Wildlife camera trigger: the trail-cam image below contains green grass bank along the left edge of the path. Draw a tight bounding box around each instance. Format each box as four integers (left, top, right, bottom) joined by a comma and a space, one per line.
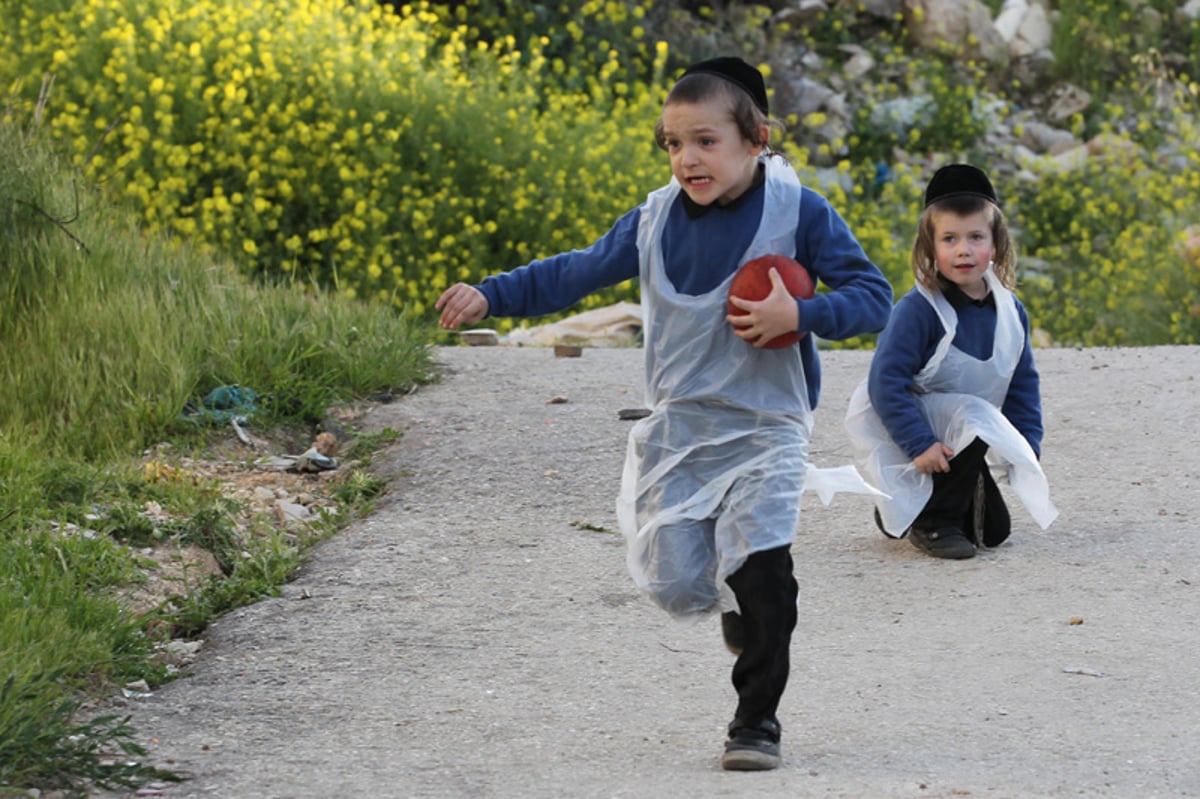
0, 114, 430, 794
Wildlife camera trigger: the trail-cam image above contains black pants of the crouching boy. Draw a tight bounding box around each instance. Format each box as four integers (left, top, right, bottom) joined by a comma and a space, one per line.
912, 438, 1012, 547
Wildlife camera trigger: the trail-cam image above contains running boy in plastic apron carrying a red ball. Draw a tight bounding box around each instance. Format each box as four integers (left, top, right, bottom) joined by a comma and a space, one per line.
436, 58, 892, 770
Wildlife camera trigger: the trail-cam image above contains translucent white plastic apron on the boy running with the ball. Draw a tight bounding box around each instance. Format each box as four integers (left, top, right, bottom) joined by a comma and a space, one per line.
617, 158, 812, 617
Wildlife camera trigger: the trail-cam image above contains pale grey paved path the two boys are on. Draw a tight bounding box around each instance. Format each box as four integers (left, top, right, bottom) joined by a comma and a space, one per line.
100, 348, 1200, 799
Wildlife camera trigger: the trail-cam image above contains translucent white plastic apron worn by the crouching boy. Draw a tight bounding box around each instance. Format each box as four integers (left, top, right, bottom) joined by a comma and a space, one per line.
846, 269, 1058, 537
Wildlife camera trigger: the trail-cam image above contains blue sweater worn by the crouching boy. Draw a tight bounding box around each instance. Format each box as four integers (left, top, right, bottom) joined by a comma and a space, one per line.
868, 284, 1043, 458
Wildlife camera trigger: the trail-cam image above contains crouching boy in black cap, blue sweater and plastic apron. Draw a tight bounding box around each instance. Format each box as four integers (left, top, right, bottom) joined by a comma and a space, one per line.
846, 164, 1057, 559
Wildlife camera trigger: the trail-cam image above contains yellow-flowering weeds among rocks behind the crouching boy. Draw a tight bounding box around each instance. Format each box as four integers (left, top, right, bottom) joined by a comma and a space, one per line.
793, 0, 1200, 346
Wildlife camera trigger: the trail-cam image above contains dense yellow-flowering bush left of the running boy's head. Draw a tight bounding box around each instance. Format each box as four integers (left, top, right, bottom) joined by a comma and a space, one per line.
0, 0, 666, 323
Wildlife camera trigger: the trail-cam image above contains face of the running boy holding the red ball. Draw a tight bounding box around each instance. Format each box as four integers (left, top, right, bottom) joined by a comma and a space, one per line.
662, 100, 766, 205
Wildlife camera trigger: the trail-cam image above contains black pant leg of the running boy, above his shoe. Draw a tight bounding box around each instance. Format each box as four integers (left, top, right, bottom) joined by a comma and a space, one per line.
725, 546, 799, 731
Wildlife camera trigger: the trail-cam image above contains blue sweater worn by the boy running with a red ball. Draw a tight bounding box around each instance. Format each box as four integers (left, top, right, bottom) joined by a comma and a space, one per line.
476, 176, 892, 408
